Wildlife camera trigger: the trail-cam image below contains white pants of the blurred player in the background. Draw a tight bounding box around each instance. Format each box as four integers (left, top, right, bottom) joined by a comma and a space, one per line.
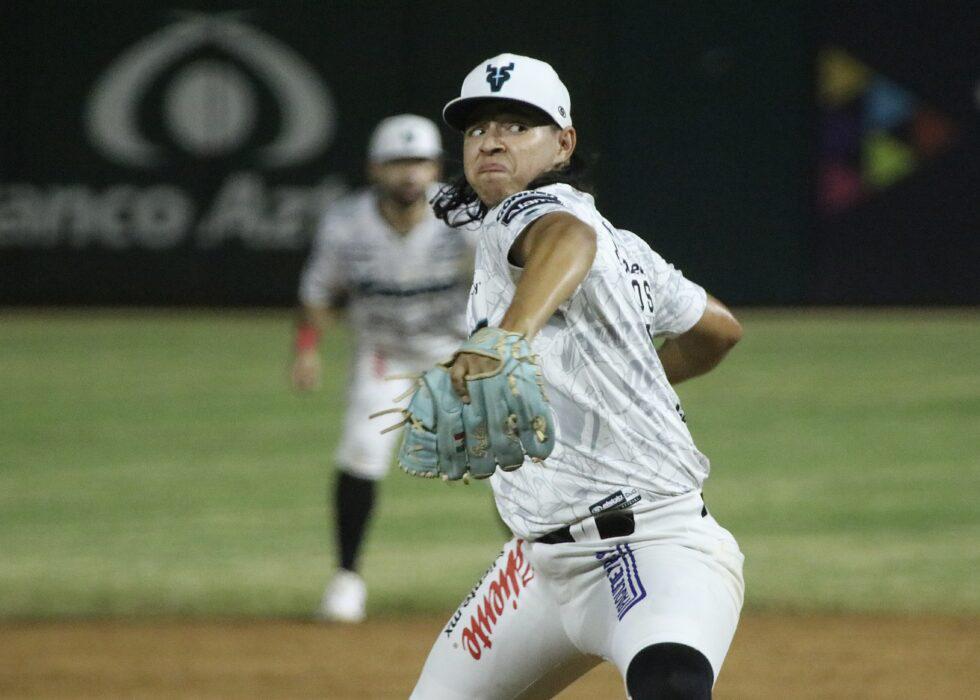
336, 348, 416, 480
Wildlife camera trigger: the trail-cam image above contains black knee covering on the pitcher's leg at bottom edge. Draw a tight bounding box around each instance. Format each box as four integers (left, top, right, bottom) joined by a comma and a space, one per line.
626, 643, 715, 700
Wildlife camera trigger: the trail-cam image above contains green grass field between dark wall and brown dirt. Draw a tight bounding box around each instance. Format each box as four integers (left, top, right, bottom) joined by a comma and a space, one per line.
0, 311, 980, 618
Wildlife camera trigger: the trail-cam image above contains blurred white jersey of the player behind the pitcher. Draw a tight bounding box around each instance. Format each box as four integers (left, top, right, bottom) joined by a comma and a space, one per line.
299, 189, 473, 358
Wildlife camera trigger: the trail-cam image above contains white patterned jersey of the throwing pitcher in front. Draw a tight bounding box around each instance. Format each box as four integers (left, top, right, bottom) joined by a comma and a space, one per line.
467, 185, 709, 539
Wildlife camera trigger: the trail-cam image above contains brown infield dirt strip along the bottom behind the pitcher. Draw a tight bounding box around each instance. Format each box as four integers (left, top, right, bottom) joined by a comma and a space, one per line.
0, 614, 980, 700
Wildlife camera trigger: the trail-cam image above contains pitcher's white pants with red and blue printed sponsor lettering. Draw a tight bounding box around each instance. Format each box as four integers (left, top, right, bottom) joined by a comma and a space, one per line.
412, 493, 744, 700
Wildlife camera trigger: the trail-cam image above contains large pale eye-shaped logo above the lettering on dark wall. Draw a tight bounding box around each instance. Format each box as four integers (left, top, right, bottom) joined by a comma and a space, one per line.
85, 15, 336, 168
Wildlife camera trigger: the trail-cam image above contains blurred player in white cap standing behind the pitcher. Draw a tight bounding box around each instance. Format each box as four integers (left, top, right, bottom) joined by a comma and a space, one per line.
293, 114, 473, 622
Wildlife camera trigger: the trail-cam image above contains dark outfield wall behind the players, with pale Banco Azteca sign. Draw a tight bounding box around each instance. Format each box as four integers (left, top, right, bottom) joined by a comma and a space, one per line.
0, 0, 980, 305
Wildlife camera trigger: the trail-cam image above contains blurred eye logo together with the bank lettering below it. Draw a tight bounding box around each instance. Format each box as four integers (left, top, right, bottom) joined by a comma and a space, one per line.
0, 13, 348, 251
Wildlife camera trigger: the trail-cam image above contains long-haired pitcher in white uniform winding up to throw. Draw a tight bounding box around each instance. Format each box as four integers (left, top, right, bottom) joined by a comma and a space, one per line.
399, 54, 743, 699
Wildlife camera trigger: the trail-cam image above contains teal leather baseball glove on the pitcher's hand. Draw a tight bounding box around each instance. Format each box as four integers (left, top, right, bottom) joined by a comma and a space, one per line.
375, 328, 555, 481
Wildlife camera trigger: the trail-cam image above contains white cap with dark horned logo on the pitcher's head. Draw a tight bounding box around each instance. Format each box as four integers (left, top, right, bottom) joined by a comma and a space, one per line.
442, 53, 572, 131
